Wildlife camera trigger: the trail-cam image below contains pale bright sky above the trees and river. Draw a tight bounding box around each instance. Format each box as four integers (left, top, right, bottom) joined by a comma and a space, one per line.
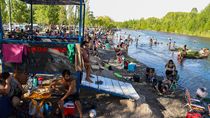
90, 0, 210, 21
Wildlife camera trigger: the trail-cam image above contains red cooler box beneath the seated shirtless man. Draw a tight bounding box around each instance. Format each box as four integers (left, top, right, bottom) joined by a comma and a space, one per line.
64, 101, 75, 116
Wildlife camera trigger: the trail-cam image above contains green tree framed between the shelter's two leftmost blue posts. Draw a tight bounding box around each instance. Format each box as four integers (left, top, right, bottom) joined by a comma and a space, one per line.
11, 0, 30, 23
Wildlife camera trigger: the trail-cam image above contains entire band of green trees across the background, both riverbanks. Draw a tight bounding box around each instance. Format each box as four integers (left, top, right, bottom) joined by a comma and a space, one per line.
0, 0, 210, 37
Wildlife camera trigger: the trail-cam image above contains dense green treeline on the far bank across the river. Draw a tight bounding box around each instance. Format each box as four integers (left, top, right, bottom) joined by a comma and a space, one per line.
116, 4, 210, 37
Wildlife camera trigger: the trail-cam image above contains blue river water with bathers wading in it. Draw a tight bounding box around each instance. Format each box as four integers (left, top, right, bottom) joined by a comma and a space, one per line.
116, 30, 210, 95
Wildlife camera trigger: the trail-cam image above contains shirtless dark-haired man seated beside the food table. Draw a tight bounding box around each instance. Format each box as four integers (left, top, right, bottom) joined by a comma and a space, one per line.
50, 70, 82, 118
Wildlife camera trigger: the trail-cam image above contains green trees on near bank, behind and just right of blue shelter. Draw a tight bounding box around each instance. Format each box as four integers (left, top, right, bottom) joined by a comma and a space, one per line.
0, 0, 115, 28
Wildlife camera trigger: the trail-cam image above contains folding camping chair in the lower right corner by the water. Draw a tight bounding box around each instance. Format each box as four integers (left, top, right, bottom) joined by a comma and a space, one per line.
185, 89, 205, 112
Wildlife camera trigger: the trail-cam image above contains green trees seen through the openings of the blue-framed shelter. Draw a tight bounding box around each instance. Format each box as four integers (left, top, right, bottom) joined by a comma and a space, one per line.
0, 0, 78, 25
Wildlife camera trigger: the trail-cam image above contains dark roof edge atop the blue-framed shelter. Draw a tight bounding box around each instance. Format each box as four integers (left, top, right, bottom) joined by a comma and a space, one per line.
21, 0, 84, 5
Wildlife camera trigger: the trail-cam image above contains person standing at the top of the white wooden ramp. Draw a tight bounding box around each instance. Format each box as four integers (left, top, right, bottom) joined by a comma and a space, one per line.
81, 41, 93, 83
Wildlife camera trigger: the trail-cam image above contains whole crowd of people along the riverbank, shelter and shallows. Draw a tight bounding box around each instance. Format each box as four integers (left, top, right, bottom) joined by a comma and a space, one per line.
0, 28, 209, 118
